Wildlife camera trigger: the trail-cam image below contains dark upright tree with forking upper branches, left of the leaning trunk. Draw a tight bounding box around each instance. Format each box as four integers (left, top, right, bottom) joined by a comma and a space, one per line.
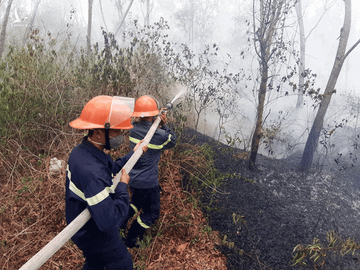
249, 0, 291, 169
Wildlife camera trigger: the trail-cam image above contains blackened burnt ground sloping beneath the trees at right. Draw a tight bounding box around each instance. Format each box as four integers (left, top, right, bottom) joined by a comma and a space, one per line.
183, 131, 360, 270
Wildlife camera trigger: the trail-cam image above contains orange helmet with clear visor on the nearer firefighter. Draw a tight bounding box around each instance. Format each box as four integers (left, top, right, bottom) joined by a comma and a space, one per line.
69, 96, 133, 129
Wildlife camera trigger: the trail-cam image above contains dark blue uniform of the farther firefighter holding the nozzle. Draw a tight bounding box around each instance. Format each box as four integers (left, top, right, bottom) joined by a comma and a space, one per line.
123, 121, 176, 247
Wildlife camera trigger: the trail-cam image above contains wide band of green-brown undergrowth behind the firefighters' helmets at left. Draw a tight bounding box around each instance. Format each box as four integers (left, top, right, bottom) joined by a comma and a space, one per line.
0, 19, 179, 151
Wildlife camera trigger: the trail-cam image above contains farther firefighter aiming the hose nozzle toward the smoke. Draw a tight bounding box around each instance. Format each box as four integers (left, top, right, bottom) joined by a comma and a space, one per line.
122, 95, 176, 248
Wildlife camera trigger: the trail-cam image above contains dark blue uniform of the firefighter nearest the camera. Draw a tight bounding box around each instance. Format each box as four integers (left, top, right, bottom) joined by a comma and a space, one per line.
66, 137, 133, 269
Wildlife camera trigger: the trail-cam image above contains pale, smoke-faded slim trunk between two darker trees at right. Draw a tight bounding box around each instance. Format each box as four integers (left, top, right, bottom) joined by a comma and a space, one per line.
295, 0, 306, 108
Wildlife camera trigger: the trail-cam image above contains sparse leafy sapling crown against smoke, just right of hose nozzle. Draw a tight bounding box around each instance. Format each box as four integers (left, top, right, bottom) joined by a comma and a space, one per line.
177, 44, 246, 133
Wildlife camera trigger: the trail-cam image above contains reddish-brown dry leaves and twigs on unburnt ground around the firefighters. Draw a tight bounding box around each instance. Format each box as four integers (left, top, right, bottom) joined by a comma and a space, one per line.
0, 140, 227, 270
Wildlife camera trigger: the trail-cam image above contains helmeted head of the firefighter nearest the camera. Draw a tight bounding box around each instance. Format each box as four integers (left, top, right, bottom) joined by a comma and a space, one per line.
69, 96, 133, 149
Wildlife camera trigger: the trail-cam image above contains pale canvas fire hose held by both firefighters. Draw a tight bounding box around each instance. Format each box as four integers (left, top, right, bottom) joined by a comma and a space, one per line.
19, 103, 173, 270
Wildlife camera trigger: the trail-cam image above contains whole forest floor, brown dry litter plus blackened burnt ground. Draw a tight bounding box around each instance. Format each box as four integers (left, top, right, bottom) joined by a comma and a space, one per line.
0, 127, 360, 270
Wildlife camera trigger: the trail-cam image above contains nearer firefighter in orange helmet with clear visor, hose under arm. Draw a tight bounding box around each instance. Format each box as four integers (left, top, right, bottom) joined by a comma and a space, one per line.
65, 96, 147, 270
